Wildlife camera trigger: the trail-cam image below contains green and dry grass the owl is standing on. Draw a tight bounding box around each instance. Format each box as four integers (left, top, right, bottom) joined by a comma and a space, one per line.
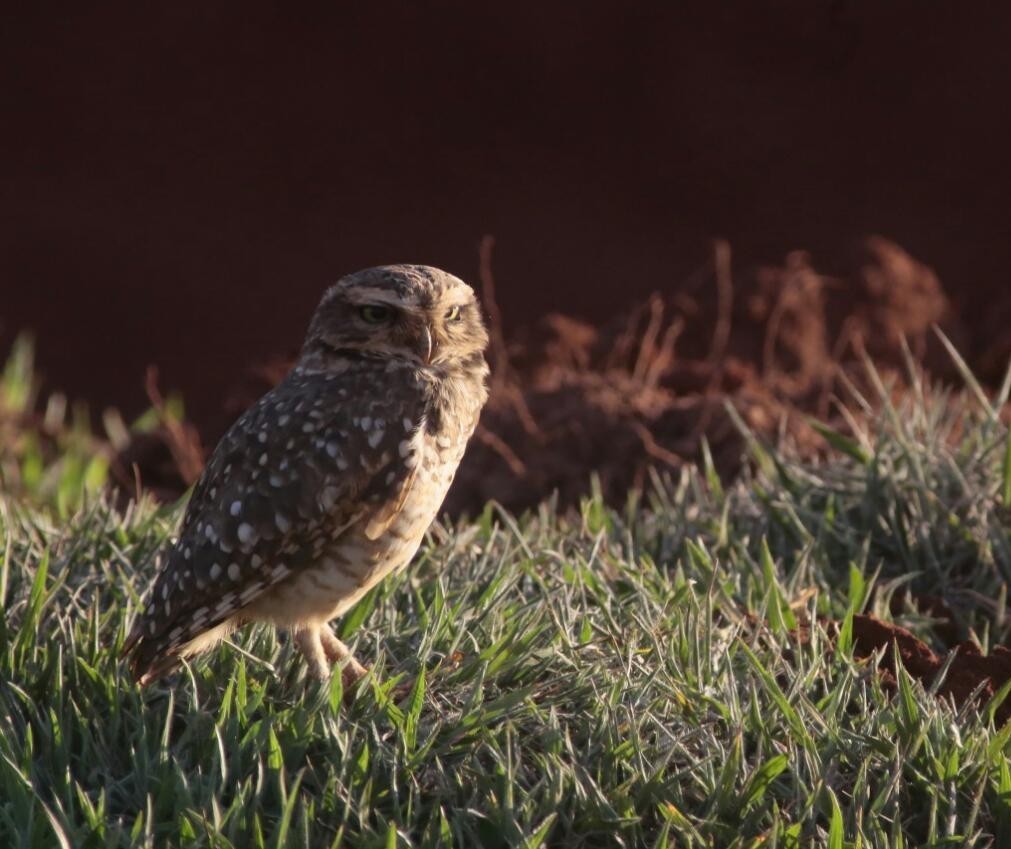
0, 341, 1011, 849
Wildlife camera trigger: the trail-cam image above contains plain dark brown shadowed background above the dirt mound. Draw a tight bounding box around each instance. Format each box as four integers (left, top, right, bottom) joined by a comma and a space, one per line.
0, 0, 1011, 419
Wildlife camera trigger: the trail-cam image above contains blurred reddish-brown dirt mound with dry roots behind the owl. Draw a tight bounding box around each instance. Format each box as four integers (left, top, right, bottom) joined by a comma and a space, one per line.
108, 237, 978, 514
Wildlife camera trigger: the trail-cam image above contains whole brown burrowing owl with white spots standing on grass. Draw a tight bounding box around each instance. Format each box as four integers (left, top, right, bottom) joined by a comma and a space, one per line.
124, 265, 488, 684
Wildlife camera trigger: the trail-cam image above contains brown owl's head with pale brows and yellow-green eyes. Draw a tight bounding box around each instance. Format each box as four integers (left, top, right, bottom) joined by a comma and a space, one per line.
302, 265, 488, 366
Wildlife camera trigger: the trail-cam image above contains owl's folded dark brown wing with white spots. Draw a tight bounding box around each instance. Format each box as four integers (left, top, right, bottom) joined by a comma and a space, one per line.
123, 364, 426, 682
